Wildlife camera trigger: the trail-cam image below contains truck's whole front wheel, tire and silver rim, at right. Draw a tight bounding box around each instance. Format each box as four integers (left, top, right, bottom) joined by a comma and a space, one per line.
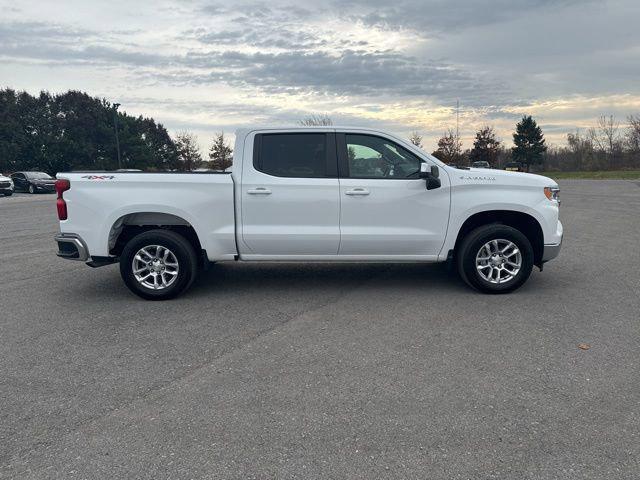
456, 224, 533, 294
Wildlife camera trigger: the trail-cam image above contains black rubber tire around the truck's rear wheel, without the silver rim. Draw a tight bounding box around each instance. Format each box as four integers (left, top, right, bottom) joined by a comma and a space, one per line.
120, 230, 198, 300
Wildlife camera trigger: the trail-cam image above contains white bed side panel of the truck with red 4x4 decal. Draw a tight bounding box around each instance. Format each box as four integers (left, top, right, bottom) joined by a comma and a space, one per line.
57, 172, 237, 260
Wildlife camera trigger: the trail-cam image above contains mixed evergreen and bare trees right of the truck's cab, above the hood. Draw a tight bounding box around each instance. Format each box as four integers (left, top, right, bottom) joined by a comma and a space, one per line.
409, 115, 640, 171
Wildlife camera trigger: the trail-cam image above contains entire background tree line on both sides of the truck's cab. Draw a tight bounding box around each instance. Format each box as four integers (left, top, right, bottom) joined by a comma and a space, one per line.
5, 88, 640, 174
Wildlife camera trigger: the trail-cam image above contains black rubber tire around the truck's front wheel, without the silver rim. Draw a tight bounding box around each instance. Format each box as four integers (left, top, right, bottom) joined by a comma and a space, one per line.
458, 225, 534, 293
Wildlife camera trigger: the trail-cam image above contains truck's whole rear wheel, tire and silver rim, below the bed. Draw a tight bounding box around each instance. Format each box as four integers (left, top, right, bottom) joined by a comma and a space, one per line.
120, 230, 198, 300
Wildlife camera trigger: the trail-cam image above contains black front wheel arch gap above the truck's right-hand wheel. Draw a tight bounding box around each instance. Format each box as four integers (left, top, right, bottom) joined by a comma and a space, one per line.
454, 210, 544, 266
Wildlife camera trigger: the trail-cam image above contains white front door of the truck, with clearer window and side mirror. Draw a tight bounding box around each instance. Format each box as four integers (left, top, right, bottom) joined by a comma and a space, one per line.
336, 133, 450, 260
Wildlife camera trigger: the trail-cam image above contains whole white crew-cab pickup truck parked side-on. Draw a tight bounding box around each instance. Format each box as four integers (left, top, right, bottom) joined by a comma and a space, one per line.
55, 127, 562, 299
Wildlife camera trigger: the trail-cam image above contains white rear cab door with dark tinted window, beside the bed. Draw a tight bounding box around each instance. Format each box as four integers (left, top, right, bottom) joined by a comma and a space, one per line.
240, 130, 340, 259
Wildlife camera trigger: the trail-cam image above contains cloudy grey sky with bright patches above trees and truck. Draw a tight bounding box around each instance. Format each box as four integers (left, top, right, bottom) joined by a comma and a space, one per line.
0, 0, 640, 150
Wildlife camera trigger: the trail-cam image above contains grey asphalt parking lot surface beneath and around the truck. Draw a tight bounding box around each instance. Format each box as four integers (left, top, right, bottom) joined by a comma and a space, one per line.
0, 181, 640, 479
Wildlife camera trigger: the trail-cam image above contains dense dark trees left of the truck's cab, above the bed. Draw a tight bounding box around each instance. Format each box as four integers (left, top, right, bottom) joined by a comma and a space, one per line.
0, 88, 233, 175
